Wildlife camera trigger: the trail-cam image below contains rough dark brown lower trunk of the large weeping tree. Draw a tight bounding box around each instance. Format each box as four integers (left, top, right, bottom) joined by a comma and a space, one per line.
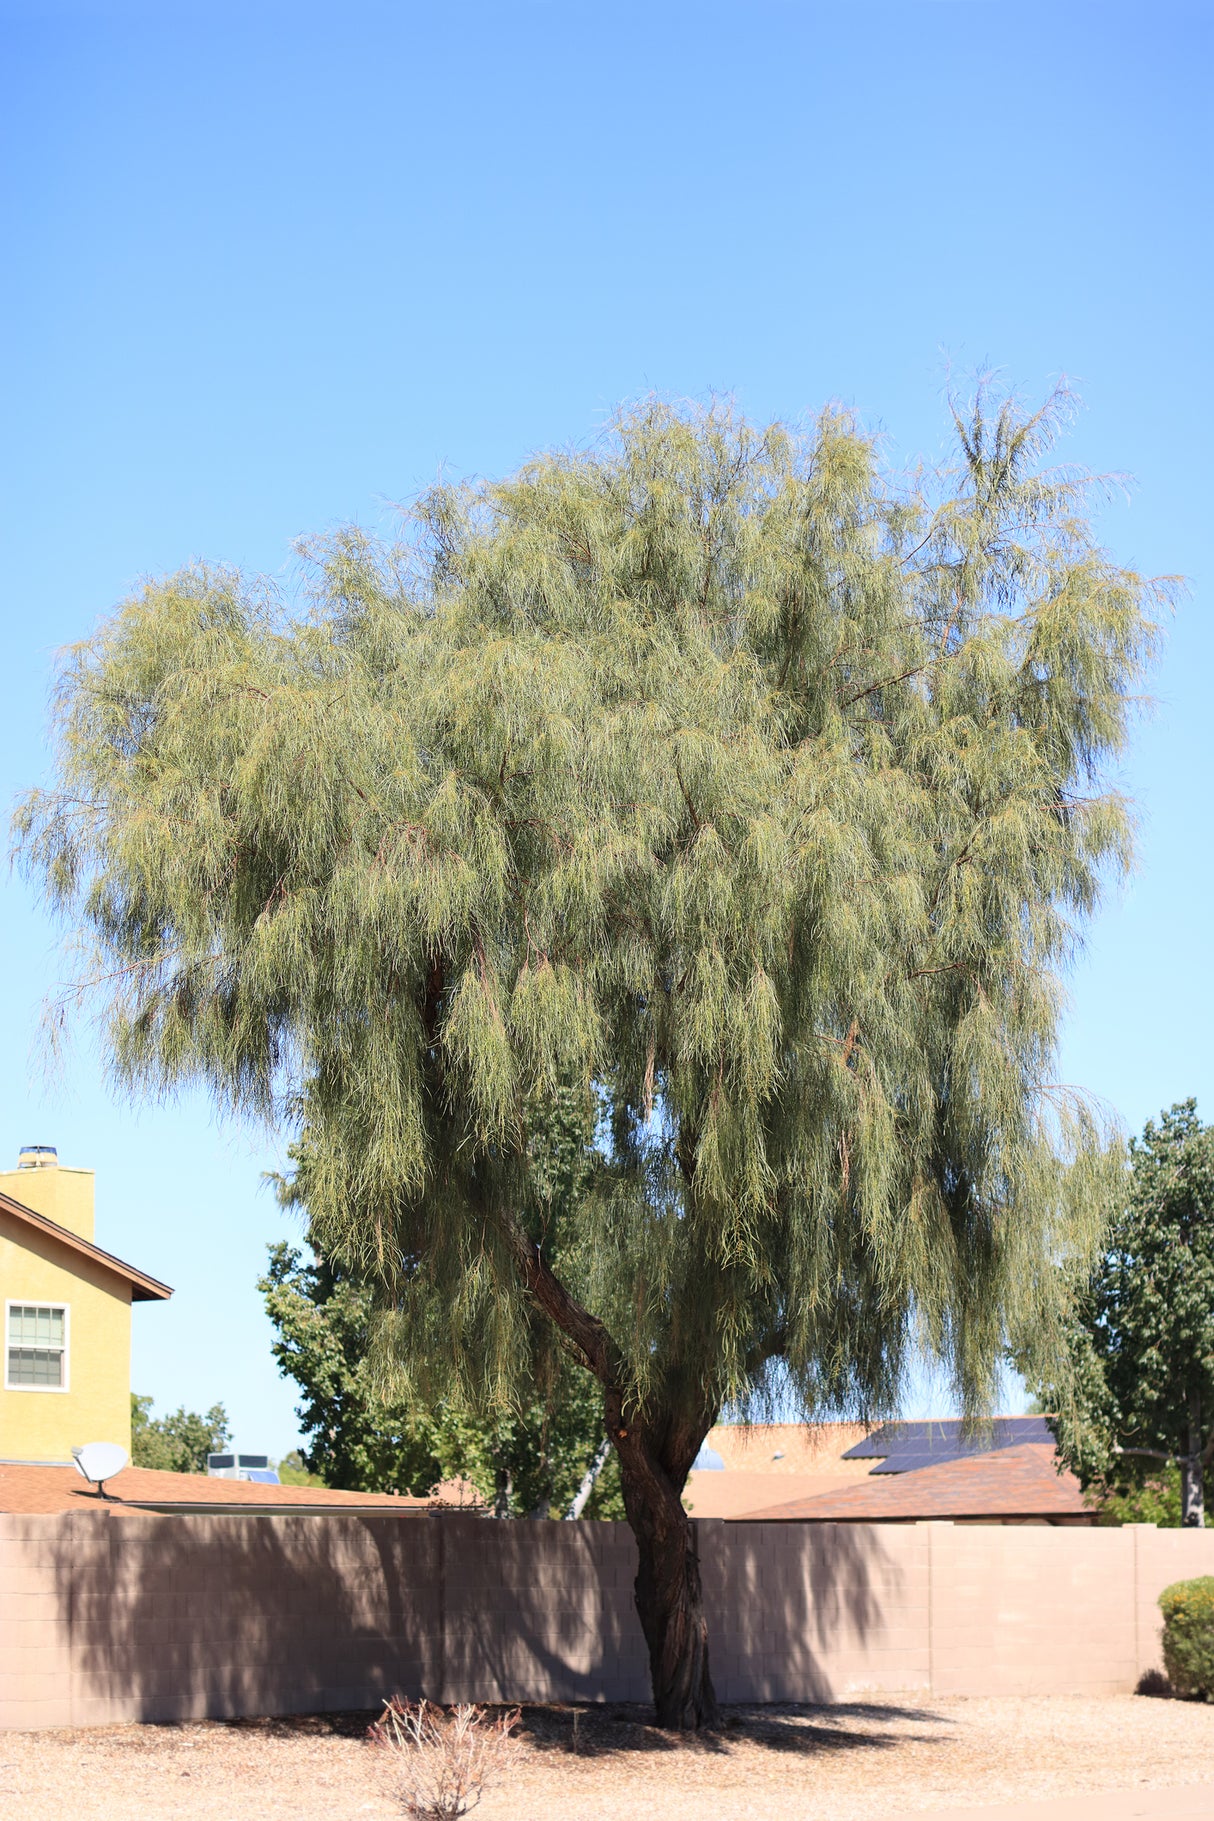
615, 1431, 717, 1732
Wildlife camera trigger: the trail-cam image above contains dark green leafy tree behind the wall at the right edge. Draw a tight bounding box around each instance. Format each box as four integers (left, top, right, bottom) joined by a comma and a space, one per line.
1047, 1100, 1214, 1526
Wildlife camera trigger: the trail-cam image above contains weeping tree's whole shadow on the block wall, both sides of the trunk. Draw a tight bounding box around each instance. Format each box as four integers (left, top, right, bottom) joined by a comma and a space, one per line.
40, 1511, 928, 1724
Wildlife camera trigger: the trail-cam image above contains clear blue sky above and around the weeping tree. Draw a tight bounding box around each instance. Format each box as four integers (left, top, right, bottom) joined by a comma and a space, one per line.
0, 0, 1214, 1451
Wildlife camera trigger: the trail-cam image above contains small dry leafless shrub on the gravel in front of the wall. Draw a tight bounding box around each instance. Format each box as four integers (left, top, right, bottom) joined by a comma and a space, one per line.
368, 1695, 519, 1821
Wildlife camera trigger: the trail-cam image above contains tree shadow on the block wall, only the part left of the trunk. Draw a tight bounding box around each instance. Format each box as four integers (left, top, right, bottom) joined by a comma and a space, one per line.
45, 1513, 648, 1724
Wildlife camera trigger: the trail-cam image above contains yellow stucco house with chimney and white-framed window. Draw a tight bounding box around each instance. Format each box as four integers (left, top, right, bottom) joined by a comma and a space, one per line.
0, 1145, 173, 1462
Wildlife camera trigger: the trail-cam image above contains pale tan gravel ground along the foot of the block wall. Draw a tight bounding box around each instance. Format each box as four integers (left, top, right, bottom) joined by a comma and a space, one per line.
0, 1695, 1214, 1821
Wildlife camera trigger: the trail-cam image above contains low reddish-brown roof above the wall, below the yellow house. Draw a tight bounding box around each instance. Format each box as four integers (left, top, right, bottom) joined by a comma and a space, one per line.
0, 1460, 433, 1517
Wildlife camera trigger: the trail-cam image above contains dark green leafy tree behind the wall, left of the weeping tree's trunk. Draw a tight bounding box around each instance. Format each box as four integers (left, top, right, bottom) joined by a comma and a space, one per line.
258, 1246, 622, 1517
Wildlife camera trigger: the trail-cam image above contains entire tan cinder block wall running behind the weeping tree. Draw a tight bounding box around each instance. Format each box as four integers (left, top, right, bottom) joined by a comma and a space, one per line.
0, 1511, 1214, 1728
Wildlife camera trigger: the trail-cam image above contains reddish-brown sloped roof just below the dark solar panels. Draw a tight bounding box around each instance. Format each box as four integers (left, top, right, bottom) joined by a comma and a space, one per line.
739, 1442, 1092, 1524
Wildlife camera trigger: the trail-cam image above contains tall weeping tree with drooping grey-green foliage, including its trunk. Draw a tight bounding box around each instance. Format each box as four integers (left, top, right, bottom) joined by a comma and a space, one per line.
18, 384, 1161, 1726
